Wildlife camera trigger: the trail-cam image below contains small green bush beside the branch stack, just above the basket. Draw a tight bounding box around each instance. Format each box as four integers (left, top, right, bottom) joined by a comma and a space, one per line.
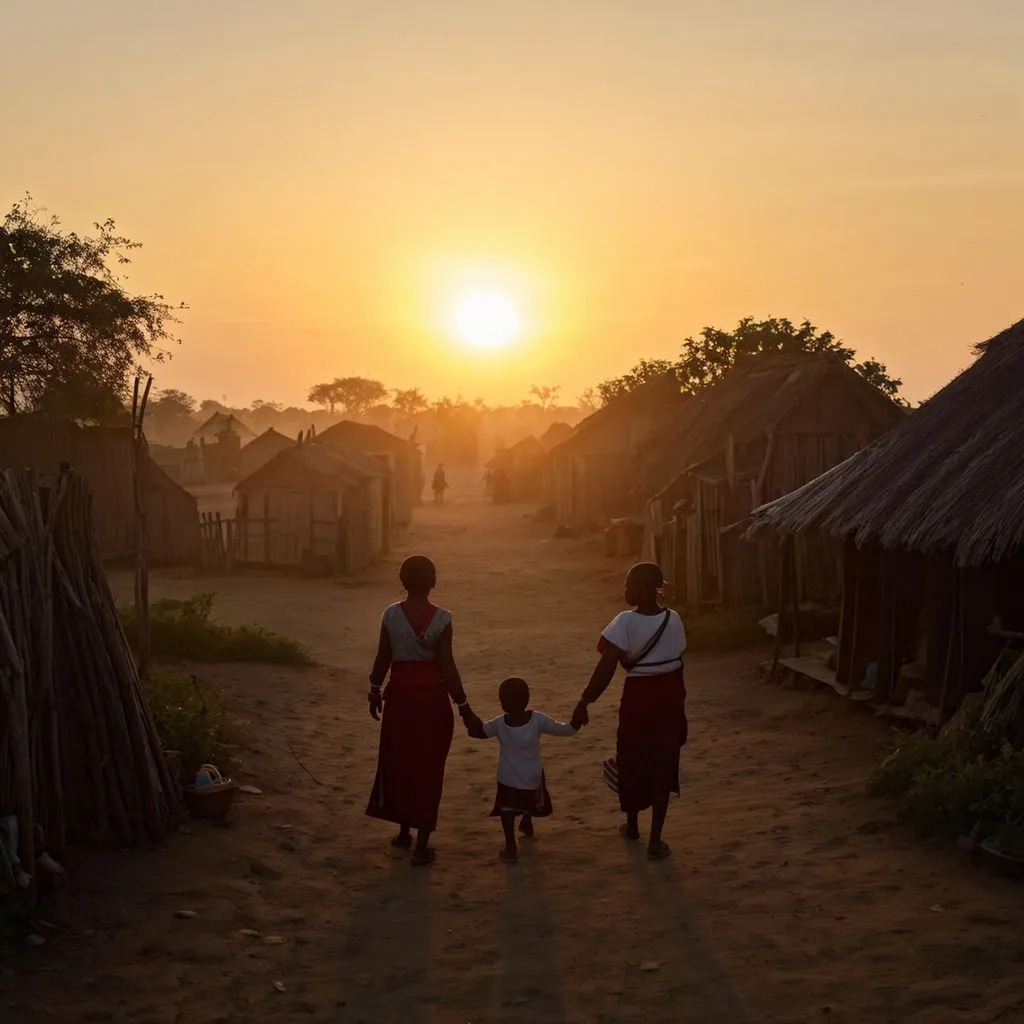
142, 669, 231, 770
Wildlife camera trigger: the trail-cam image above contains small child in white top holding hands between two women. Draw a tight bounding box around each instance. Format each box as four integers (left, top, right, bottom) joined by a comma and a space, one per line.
465, 679, 580, 864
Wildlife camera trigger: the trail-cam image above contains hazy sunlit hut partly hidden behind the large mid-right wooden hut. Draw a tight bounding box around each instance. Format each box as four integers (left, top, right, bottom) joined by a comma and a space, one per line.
551, 374, 684, 534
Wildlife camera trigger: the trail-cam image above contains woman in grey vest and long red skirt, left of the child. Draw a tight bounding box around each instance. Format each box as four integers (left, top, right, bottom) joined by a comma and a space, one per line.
367, 555, 469, 866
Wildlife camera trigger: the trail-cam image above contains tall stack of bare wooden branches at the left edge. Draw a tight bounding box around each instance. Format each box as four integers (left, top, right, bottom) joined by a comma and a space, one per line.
0, 467, 173, 880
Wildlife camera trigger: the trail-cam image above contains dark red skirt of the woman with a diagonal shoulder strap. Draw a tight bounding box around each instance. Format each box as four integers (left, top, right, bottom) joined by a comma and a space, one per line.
615, 669, 687, 814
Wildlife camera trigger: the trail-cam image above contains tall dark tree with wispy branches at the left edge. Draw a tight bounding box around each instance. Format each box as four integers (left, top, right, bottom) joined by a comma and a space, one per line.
0, 197, 184, 420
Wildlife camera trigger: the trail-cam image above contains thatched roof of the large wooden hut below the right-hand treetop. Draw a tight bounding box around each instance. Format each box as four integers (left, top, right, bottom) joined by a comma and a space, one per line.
638, 352, 905, 494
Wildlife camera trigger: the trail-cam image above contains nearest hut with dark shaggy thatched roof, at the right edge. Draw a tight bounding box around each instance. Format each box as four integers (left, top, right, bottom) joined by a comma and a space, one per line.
751, 321, 1024, 722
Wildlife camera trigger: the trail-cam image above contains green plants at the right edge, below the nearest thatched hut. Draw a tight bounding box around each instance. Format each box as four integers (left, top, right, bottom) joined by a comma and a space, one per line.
868, 735, 1024, 856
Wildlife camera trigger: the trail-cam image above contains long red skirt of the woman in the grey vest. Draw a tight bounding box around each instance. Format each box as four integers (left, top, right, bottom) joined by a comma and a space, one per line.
367, 662, 455, 831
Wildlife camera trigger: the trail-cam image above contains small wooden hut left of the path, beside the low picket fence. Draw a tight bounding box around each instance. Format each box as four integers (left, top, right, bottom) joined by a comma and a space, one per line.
234, 443, 392, 575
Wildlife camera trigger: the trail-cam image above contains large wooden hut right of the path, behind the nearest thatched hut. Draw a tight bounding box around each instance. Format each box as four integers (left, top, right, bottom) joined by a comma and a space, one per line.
638, 353, 905, 610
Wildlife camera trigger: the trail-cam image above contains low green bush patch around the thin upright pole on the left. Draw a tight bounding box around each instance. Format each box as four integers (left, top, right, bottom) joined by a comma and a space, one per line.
119, 594, 312, 665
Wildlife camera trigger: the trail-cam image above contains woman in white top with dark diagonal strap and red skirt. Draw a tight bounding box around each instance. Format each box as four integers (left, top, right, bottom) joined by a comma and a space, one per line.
572, 562, 687, 860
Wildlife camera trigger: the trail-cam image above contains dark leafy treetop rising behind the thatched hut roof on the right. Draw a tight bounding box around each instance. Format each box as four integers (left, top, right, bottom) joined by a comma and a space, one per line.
677, 316, 903, 398
